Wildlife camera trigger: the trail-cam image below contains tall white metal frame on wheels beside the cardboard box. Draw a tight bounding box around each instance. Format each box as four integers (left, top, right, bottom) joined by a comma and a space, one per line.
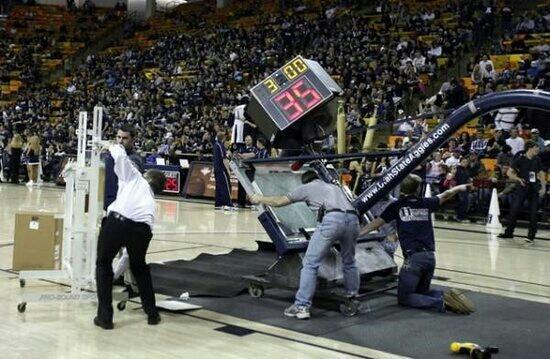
18, 106, 127, 312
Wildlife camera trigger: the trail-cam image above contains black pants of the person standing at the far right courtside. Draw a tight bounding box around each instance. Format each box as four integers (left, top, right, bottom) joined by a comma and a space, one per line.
506, 184, 539, 238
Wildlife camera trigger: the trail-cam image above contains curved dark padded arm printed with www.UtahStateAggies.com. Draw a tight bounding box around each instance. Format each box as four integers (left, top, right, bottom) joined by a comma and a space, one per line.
353, 90, 550, 213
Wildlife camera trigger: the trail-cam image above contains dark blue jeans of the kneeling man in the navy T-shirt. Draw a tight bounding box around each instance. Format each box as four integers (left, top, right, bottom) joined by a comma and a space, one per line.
397, 251, 445, 312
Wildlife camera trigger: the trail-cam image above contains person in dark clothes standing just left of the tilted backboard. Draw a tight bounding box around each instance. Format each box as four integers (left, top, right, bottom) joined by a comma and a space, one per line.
212, 131, 234, 210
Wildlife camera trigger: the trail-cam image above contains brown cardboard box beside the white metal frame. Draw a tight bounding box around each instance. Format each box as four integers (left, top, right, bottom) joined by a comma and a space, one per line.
13, 211, 63, 270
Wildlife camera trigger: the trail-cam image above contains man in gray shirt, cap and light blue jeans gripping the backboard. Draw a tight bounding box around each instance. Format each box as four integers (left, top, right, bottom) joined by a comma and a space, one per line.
250, 171, 359, 319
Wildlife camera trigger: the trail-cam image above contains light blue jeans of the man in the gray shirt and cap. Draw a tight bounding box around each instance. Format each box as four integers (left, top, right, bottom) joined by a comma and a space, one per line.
294, 212, 360, 307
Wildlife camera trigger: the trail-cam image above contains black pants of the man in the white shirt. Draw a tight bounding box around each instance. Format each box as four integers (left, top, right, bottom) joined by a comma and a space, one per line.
96, 213, 158, 322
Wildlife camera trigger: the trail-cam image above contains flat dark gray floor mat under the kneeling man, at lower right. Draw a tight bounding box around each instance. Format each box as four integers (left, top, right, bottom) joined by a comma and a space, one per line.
192, 289, 550, 359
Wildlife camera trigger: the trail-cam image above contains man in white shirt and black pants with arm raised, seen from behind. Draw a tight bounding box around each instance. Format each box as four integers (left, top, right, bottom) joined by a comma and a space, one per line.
94, 144, 166, 329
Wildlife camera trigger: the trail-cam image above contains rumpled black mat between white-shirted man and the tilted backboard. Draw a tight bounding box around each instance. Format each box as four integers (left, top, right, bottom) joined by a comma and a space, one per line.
151, 249, 277, 297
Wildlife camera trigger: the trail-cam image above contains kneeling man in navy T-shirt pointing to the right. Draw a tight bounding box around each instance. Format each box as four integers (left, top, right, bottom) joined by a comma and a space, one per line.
361, 175, 474, 314
